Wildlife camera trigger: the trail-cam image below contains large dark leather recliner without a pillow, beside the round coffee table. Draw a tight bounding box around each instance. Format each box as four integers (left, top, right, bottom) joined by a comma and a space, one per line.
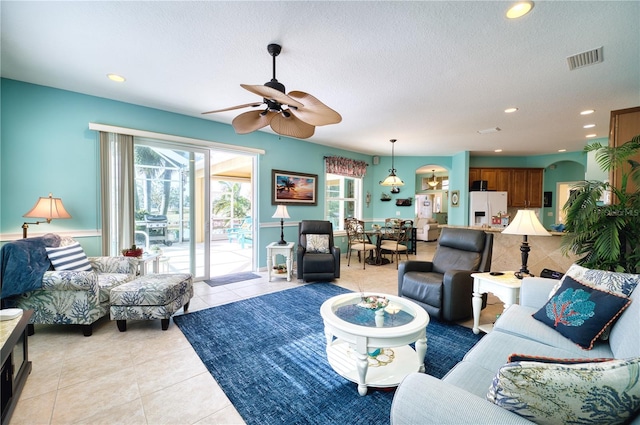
398, 228, 493, 321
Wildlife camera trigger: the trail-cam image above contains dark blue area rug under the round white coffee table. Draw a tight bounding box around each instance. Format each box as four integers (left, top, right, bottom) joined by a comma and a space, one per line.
174, 283, 480, 425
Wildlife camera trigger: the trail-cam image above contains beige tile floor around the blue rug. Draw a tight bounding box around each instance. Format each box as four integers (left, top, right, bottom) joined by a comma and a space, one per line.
10, 242, 502, 425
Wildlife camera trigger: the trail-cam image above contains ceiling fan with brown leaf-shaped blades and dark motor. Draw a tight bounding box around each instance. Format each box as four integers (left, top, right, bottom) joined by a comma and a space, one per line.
203, 44, 342, 139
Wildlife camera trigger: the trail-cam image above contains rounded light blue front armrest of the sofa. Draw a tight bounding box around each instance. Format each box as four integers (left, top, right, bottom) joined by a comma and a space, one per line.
390, 373, 532, 425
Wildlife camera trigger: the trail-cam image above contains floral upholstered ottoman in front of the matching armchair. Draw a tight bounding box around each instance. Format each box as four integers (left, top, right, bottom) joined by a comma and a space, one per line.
110, 273, 193, 332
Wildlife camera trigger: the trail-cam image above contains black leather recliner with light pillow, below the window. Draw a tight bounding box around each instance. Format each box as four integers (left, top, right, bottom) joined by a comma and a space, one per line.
297, 220, 340, 282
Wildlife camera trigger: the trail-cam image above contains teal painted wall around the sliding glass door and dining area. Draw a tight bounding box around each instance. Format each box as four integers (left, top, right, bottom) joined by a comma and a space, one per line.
0, 79, 587, 267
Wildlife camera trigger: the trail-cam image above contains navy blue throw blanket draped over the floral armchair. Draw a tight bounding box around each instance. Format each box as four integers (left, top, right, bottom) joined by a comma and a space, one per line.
0, 233, 60, 299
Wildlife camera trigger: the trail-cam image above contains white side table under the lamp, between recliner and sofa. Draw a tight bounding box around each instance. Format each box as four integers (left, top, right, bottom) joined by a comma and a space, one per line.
471, 272, 522, 334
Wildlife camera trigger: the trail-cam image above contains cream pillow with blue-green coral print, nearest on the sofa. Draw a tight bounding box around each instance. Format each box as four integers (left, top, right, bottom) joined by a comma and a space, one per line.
487, 357, 640, 424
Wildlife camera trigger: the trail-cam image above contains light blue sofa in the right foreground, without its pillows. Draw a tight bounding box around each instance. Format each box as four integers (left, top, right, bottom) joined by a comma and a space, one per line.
390, 278, 640, 425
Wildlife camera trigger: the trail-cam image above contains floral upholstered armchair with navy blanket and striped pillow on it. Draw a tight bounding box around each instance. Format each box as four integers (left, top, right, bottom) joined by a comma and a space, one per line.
2, 234, 138, 336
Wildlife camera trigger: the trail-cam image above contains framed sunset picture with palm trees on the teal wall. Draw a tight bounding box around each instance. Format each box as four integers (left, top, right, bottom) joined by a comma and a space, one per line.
271, 170, 318, 205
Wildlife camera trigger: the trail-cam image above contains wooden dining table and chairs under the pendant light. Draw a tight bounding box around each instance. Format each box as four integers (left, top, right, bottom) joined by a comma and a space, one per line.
344, 218, 413, 269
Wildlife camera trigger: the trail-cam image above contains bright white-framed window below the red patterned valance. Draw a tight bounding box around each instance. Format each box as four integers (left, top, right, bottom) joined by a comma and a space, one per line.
325, 173, 362, 230
